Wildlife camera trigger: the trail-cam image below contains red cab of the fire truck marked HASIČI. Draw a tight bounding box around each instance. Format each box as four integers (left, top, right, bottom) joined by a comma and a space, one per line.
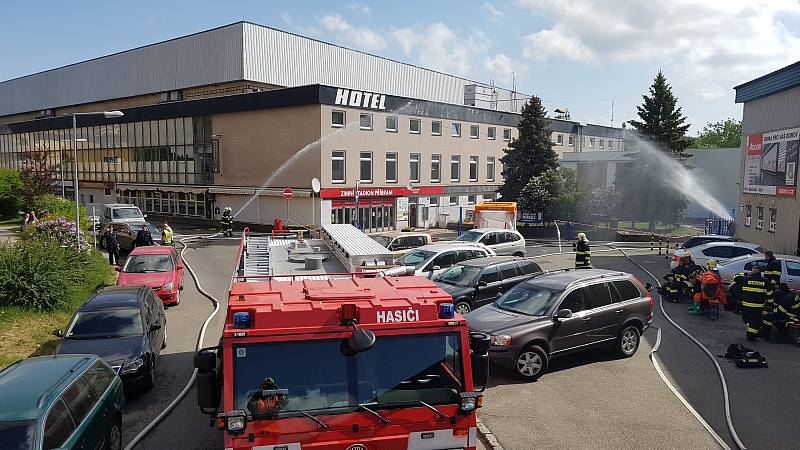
195, 232, 489, 450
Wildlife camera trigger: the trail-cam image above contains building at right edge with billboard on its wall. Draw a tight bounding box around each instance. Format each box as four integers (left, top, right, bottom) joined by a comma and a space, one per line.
735, 62, 800, 255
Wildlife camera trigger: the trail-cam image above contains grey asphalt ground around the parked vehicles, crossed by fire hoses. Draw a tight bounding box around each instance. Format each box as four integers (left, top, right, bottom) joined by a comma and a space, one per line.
115, 240, 800, 449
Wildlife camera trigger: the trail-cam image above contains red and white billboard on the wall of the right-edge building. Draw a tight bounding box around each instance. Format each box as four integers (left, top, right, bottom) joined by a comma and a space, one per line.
744, 127, 800, 197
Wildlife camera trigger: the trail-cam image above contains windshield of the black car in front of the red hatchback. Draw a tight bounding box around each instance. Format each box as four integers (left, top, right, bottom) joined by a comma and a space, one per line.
65, 309, 142, 339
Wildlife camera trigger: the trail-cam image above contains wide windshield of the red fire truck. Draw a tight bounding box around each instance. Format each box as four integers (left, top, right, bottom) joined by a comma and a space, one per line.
232, 333, 464, 419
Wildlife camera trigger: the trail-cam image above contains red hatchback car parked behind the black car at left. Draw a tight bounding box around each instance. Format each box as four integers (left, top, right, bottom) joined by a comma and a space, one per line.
117, 245, 183, 305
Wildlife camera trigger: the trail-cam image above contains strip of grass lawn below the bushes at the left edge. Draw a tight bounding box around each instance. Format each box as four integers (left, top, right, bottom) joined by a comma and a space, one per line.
0, 250, 116, 369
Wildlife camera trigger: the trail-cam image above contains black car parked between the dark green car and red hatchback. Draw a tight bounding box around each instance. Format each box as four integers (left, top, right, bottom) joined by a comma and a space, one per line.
56, 286, 167, 389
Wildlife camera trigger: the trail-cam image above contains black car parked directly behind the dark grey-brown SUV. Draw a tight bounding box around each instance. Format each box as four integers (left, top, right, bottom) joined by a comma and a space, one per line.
433, 256, 542, 315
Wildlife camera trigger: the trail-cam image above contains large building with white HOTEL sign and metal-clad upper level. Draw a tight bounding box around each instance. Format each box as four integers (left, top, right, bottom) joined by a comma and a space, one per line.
0, 22, 618, 230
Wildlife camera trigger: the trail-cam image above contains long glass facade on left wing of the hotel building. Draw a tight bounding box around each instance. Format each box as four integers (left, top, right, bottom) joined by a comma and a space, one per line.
0, 116, 214, 185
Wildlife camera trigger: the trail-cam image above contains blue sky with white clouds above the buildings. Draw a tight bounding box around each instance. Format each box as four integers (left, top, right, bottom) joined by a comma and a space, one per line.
0, 0, 800, 133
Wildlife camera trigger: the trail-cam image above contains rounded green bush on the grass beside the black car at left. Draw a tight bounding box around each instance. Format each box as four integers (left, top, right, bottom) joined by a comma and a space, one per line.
0, 239, 111, 310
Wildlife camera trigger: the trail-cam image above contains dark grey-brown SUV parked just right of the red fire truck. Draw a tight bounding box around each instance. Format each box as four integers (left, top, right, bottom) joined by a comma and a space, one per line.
466, 269, 653, 380
